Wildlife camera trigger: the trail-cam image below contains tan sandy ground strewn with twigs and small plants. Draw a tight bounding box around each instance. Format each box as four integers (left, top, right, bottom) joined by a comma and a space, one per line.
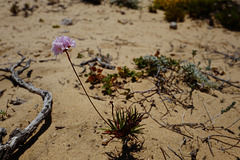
0, 0, 240, 160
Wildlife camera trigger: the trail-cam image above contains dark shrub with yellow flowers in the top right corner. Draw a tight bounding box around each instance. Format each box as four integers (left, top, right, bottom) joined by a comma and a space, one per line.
151, 0, 240, 31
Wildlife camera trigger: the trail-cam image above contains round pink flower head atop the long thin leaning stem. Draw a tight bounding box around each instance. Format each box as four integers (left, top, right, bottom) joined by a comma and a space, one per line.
52, 36, 76, 55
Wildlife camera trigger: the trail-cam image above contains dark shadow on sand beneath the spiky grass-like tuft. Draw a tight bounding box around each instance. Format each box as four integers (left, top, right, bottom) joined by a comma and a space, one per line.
105, 141, 144, 160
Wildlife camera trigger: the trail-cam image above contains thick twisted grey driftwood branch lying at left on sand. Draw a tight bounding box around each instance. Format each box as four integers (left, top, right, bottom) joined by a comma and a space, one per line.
0, 52, 52, 160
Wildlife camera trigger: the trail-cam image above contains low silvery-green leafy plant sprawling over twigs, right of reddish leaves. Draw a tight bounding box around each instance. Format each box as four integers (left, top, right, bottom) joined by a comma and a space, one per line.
133, 51, 218, 90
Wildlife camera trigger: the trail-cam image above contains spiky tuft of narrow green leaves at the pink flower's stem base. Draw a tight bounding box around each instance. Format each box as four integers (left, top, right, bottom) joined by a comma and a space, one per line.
103, 103, 144, 143
